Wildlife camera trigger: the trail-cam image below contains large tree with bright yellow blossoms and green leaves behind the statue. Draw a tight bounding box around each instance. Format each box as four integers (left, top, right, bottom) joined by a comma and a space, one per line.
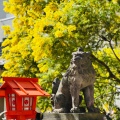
2, 0, 120, 118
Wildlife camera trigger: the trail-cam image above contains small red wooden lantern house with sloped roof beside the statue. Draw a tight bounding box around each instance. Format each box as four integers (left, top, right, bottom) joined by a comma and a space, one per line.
0, 77, 49, 120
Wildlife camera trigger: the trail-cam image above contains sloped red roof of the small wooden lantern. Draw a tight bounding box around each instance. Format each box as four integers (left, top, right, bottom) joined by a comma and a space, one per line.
0, 77, 50, 96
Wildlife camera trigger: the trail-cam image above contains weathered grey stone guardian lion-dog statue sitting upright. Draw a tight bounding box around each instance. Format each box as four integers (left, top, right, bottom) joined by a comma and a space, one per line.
52, 48, 99, 113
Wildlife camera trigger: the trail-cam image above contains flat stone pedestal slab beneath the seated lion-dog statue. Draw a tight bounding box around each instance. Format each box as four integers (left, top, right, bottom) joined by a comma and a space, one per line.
42, 113, 106, 120
